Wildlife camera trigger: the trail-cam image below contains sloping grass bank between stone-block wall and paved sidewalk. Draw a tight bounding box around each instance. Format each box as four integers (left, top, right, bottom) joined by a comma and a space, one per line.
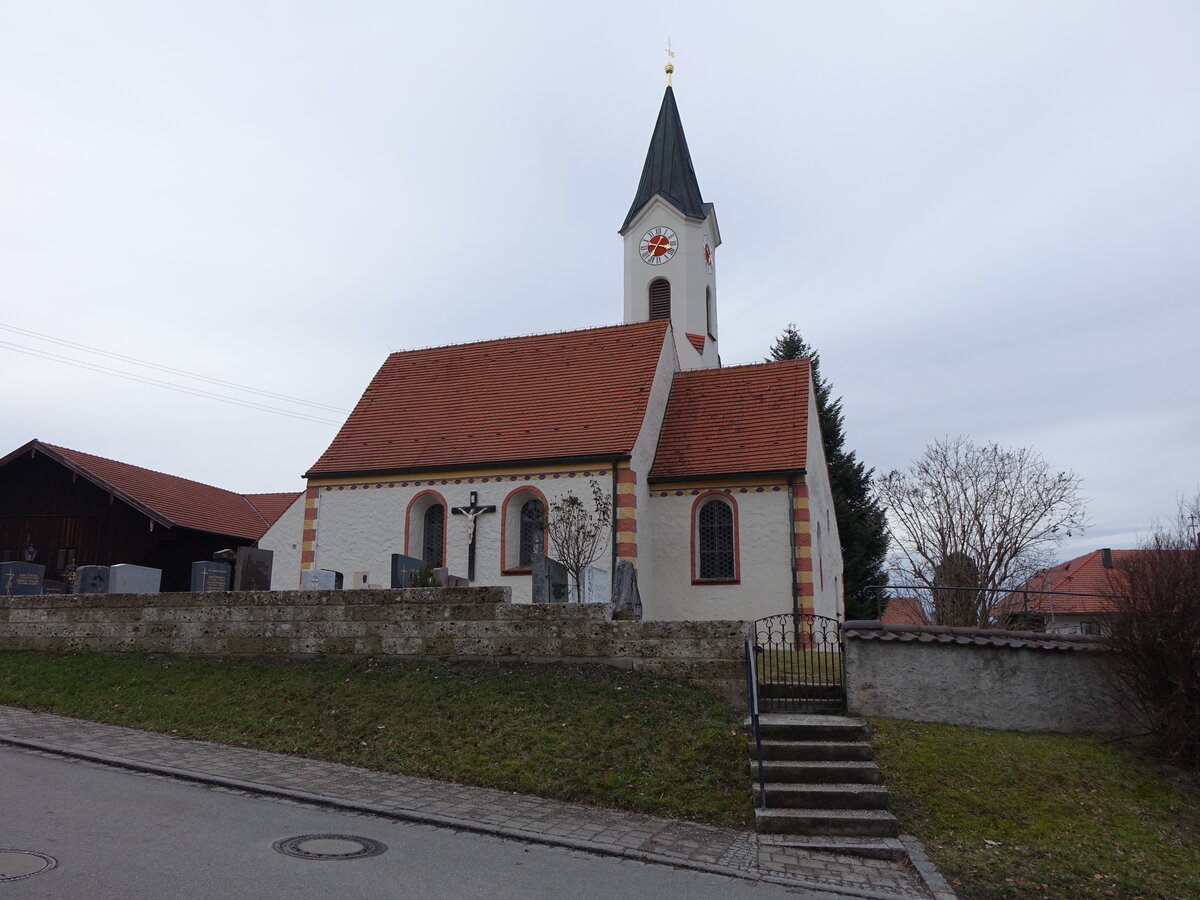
0, 653, 754, 827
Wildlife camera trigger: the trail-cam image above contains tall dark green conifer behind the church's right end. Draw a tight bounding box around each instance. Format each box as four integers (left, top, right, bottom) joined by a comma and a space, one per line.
770, 323, 888, 619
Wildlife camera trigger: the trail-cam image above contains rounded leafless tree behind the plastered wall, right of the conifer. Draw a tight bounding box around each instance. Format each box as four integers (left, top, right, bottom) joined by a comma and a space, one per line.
878, 437, 1088, 628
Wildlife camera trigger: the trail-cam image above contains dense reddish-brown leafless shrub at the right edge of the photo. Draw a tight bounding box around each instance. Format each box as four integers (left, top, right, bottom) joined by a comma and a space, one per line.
1104, 493, 1200, 769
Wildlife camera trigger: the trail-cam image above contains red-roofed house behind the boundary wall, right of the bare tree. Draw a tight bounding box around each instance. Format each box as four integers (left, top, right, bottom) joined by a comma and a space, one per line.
995, 547, 1150, 635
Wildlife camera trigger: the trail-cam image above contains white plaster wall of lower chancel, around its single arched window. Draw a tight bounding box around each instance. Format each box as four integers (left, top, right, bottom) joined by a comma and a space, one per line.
642, 485, 792, 620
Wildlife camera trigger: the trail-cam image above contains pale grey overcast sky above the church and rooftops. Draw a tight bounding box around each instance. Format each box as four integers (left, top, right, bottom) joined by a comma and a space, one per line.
0, 0, 1200, 558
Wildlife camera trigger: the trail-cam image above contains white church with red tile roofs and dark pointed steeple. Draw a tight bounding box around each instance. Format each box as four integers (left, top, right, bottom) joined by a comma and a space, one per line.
259, 70, 842, 619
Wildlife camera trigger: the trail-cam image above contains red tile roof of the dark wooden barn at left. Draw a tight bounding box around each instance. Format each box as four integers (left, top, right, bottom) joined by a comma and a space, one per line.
12, 440, 300, 540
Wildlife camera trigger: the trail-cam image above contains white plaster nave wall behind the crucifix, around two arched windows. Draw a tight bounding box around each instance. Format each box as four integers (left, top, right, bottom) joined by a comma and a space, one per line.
313, 466, 612, 604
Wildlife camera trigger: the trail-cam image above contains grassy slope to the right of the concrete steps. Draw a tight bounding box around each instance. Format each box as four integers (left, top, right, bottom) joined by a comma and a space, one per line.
872, 719, 1200, 900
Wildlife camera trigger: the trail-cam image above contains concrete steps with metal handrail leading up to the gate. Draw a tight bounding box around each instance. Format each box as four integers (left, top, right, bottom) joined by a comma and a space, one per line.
746, 713, 906, 859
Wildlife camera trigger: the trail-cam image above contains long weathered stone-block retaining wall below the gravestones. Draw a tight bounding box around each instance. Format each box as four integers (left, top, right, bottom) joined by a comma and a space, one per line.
0, 587, 745, 702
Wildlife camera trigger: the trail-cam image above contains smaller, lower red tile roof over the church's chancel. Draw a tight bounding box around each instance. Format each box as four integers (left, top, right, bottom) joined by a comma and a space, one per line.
650, 359, 810, 479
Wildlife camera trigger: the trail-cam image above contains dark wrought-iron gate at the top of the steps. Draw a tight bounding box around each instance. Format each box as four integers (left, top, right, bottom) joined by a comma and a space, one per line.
754, 612, 846, 713
